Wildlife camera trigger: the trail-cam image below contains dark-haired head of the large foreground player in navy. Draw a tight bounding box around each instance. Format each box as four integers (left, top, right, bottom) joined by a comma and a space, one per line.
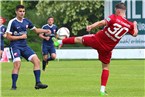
15, 5, 25, 19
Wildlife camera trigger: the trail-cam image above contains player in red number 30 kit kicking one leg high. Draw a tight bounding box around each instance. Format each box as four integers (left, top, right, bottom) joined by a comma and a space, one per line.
54, 3, 138, 95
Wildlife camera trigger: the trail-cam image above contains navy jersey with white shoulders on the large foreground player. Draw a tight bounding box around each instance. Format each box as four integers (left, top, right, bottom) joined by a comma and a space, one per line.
6, 18, 35, 46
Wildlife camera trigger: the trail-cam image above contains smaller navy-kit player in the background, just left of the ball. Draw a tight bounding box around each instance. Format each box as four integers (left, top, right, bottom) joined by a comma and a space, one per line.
39, 17, 58, 71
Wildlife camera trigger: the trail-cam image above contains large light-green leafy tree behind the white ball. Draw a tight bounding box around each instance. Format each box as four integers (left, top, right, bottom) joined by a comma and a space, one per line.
36, 0, 104, 35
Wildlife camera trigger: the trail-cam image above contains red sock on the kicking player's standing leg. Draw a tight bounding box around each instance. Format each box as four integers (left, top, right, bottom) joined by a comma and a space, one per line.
101, 70, 109, 86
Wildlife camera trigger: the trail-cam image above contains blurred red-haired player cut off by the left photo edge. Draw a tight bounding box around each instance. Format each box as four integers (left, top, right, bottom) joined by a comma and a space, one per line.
0, 16, 6, 60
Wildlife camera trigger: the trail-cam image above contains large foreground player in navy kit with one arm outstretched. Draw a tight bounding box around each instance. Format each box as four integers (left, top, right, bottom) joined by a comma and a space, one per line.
6, 5, 51, 90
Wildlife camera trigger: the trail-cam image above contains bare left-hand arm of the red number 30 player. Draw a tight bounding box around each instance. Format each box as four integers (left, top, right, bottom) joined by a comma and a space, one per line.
86, 20, 106, 32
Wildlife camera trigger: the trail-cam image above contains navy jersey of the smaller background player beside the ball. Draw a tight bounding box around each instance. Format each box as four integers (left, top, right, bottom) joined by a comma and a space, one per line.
42, 24, 58, 45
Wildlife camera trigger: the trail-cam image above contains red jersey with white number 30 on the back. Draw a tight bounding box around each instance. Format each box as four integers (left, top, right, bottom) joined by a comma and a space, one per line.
95, 14, 134, 51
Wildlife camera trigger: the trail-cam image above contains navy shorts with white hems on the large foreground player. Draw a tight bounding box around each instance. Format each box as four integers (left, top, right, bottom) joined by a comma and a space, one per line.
10, 46, 35, 62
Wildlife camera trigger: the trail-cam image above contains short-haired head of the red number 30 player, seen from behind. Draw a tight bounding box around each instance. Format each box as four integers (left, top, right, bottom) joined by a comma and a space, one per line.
115, 2, 126, 17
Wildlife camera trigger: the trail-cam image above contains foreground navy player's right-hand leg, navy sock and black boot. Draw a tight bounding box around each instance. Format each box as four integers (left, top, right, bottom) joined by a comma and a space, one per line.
29, 54, 48, 89
